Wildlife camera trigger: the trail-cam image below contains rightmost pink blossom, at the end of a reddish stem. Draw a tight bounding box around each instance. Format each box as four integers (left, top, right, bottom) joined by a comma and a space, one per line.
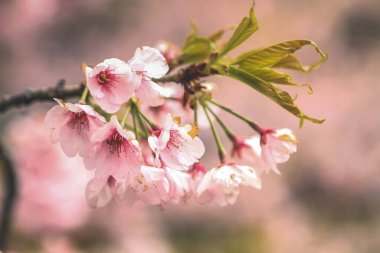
260, 128, 297, 174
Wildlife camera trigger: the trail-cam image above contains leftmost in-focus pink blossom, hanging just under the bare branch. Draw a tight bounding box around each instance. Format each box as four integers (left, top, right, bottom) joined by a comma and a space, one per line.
45, 99, 105, 157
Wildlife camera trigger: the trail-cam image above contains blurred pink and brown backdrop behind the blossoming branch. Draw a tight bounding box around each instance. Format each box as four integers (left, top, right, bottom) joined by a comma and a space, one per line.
0, 0, 380, 253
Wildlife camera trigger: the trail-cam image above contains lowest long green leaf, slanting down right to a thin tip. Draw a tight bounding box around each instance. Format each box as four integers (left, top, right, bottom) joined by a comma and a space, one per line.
224, 66, 325, 126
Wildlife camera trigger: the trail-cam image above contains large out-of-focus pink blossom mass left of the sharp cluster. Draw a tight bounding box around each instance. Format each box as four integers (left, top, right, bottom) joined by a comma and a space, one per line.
4, 114, 89, 234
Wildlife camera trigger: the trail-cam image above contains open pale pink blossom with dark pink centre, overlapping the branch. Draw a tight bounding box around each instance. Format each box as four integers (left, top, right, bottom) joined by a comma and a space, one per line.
86, 58, 140, 113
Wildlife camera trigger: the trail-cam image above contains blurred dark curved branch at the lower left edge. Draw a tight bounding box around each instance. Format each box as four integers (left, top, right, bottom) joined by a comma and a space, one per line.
0, 143, 17, 252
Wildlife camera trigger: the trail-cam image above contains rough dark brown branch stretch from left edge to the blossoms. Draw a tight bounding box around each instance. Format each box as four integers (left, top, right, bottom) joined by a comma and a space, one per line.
0, 80, 84, 113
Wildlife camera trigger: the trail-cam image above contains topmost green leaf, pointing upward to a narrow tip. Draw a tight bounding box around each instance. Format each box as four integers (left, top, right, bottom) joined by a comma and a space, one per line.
220, 7, 259, 57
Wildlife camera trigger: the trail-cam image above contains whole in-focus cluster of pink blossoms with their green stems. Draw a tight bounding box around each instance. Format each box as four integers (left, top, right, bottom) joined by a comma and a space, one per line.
45, 44, 296, 208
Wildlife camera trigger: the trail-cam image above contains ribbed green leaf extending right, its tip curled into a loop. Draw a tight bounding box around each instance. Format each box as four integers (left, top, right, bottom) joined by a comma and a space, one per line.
234, 40, 327, 71
